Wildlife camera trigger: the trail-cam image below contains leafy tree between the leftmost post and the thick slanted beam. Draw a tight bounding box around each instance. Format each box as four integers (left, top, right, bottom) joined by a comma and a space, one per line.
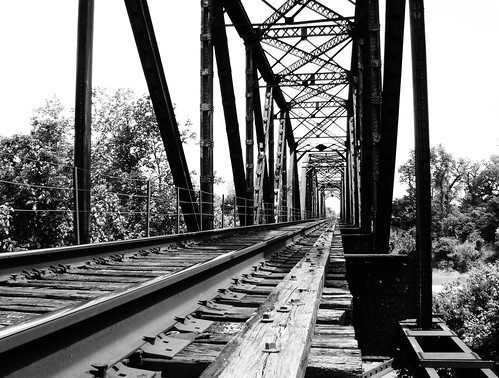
92, 89, 195, 241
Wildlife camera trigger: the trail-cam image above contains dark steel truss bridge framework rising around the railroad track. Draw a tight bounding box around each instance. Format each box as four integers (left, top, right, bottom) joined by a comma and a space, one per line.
1, 0, 493, 376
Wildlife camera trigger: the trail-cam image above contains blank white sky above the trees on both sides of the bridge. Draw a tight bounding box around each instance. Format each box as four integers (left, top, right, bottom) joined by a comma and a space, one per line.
0, 0, 499, 201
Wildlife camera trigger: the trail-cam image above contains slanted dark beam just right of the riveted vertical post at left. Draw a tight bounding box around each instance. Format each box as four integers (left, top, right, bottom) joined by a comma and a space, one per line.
212, 0, 246, 225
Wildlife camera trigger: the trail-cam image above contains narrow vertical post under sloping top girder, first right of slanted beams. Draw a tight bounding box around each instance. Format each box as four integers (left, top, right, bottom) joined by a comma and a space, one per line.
244, 42, 258, 225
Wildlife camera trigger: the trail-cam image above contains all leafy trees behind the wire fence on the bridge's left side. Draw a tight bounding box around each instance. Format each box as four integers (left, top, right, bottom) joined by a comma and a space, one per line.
0, 89, 195, 251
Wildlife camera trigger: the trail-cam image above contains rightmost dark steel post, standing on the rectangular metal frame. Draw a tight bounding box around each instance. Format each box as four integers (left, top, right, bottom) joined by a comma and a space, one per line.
409, 0, 432, 329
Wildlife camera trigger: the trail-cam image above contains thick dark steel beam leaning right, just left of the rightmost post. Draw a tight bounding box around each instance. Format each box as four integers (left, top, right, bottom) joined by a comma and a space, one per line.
374, 0, 405, 253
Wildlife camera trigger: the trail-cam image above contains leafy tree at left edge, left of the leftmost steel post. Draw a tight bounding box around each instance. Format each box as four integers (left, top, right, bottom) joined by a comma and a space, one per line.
0, 97, 73, 249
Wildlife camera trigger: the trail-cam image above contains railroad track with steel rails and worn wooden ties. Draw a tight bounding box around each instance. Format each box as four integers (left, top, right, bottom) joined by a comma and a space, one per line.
0, 222, 356, 377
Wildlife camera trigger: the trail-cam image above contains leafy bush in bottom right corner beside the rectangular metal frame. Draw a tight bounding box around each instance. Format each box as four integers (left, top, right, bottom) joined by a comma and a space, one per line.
433, 262, 499, 366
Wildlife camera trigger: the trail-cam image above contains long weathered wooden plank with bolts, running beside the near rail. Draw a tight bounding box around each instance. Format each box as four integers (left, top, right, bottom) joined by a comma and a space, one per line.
197, 232, 332, 378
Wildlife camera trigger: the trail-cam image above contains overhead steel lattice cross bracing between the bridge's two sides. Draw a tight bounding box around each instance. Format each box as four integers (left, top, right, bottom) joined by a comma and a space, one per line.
242, 0, 355, 157
